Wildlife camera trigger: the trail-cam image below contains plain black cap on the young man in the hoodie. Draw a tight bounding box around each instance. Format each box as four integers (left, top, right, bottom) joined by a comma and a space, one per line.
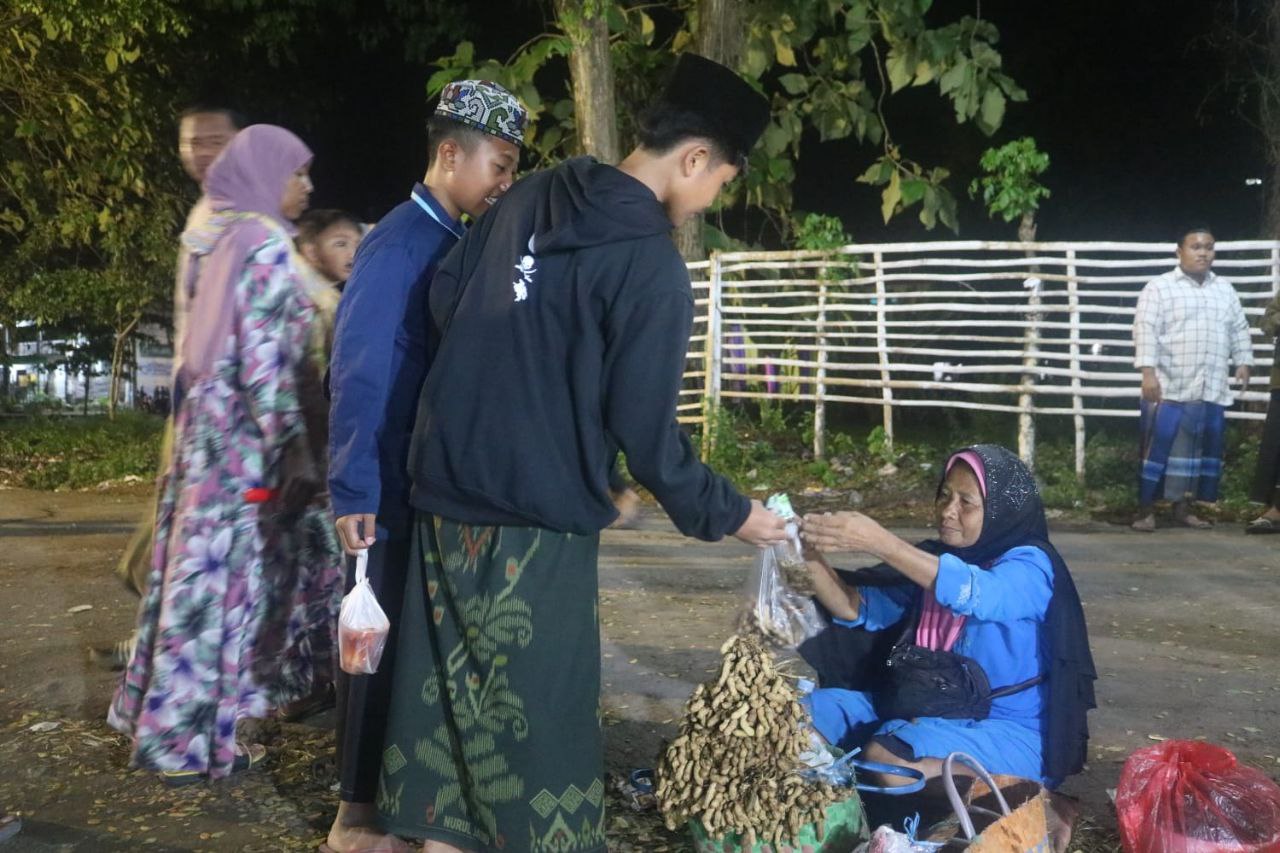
659, 54, 769, 158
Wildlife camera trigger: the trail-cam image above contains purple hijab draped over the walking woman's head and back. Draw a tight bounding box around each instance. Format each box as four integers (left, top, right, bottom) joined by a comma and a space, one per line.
174, 124, 312, 389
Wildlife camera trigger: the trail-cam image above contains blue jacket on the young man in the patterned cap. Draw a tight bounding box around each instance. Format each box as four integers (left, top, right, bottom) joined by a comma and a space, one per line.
329, 183, 463, 521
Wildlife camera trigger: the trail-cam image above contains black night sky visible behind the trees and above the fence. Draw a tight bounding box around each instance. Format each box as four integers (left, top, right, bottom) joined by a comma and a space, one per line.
242, 0, 1270, 242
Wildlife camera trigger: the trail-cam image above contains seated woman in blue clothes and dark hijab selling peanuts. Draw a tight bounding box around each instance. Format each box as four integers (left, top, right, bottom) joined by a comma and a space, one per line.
801, 444, 1096, 786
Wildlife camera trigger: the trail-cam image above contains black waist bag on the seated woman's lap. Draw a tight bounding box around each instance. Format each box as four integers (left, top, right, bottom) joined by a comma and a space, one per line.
872, 596, 1044, 720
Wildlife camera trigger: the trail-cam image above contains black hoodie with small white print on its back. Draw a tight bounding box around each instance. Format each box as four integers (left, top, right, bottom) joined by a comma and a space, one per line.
410, 158, 750, 539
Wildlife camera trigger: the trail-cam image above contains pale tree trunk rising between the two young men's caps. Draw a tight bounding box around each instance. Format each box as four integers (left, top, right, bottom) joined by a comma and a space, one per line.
556, 0, 622, 164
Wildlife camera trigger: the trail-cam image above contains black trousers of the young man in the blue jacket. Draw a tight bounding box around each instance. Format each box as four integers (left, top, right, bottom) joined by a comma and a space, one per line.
335, 517, 413, 803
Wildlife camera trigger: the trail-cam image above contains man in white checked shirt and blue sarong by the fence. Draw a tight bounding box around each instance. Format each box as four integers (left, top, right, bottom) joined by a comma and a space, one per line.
1133, 228, 1253, 532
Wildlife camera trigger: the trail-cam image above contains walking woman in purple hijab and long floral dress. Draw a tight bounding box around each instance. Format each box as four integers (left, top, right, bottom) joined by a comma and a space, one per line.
108, 124, 342, 784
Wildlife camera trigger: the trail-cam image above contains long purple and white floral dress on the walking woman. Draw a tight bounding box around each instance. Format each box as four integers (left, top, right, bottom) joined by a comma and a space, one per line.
108, 228, 342, 777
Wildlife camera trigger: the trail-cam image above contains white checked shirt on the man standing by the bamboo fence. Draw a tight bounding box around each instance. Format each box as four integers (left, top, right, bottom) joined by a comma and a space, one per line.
1133, 266, 1253, 406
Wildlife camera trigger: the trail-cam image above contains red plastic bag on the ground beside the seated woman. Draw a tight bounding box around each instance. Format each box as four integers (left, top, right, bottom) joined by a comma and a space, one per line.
1116, 740, 1280, 853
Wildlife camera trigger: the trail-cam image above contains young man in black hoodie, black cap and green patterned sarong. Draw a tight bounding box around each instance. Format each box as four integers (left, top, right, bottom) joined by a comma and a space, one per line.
379, 54, 785, 852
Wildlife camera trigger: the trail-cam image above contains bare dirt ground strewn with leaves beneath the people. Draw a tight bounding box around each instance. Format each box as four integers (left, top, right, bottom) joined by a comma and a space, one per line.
0, 489, 1280, 853
